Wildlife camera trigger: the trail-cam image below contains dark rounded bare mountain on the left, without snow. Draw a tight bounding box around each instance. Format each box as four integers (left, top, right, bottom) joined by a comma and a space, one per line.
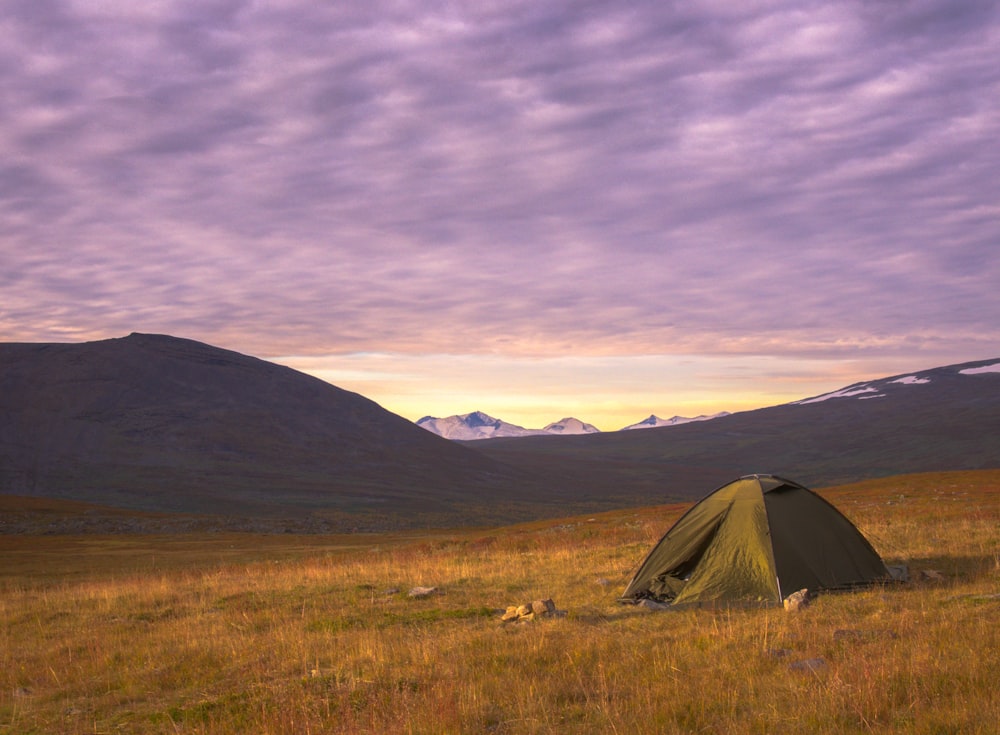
0, 334, 552, 525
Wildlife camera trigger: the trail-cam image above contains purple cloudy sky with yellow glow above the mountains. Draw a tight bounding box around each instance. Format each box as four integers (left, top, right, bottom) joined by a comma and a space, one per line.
0, 0, 1000, 430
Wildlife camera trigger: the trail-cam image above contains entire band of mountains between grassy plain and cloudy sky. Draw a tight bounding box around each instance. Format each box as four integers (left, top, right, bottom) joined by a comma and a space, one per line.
0, 334, 1000, 533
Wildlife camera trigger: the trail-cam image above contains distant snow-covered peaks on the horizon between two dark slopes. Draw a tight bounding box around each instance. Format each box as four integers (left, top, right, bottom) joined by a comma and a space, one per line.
417, 411, 729, 441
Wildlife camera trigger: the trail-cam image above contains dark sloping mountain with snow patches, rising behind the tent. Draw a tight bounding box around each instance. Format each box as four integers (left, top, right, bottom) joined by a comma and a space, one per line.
477, 358, 1000, 502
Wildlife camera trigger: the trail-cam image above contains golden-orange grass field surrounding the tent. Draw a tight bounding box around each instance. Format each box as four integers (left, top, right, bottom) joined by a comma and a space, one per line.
0, 471, 1000, 734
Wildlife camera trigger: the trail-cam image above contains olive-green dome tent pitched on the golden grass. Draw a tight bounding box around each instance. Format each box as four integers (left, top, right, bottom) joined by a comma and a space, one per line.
622, 475, 889, 604
